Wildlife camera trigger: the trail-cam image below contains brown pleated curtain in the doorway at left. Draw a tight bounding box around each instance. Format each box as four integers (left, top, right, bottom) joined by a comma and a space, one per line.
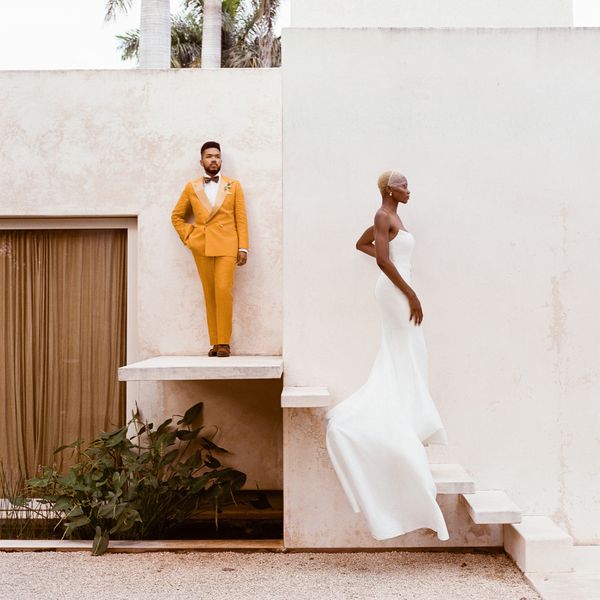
0, 229, 127, 479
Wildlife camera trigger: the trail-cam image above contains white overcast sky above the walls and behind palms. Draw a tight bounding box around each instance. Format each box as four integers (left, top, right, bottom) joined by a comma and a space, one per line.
0, 0, 600, 70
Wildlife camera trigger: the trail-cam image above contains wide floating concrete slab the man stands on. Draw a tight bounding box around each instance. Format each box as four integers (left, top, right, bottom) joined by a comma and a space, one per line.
119, 356, 283, 381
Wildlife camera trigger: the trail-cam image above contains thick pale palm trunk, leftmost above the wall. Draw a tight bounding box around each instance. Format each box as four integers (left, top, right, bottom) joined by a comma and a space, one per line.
139, 0, 171, 69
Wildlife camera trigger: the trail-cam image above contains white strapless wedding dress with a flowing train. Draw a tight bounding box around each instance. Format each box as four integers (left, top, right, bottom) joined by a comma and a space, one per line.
327, 230, 449, 540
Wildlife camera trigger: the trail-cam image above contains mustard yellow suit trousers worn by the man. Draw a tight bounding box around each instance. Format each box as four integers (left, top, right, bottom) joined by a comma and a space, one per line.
193, 252, 237, 346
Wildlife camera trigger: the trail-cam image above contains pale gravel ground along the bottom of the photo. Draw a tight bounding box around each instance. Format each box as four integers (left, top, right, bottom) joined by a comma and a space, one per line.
0, 552, 540, 600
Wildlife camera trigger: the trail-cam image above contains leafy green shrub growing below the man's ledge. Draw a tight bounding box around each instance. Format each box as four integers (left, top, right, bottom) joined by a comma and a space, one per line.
27, 402, 246, 555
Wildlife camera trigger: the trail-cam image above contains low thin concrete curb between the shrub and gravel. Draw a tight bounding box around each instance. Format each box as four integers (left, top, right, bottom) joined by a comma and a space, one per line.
0, 540, 284, 553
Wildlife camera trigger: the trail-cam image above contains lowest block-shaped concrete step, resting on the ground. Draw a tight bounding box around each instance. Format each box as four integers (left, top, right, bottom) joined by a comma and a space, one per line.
504, 516, 573, 573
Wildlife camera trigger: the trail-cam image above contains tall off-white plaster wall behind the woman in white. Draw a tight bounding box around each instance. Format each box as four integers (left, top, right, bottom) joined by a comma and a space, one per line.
283, 29, 600, 546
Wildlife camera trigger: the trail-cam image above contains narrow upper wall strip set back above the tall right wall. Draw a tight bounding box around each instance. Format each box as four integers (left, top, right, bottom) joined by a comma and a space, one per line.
291, 0, 573, 27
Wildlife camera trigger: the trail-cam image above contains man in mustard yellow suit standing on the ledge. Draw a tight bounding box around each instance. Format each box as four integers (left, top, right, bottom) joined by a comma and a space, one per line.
171, 142, 248, 357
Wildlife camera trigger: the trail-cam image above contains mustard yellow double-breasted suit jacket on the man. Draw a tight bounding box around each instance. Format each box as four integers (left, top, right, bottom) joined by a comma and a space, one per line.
171, 176, 248, 256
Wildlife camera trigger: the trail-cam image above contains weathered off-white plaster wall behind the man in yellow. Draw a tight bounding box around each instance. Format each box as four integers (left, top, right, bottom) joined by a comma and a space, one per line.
0, 70, 282, 488
